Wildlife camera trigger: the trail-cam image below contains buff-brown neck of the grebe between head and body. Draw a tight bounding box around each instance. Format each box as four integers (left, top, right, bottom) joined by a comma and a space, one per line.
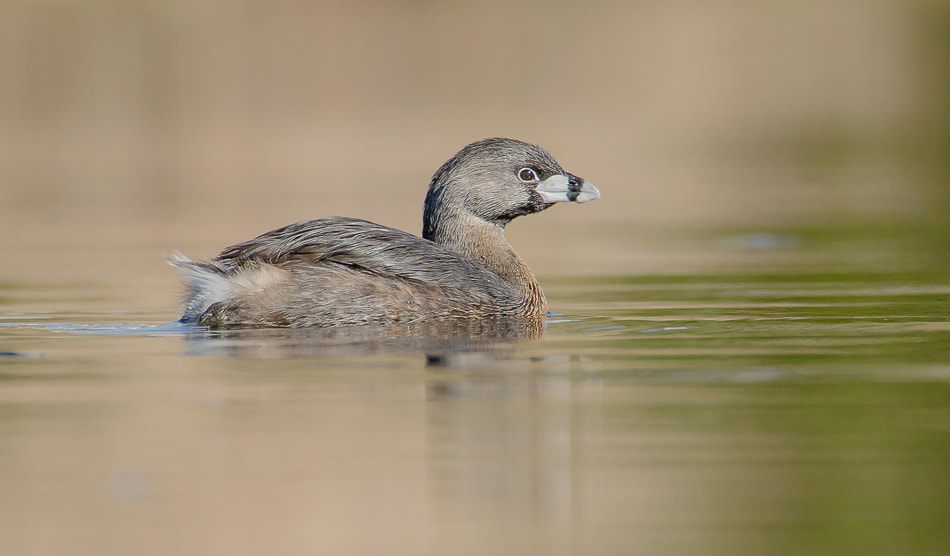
423, 212, 547, 312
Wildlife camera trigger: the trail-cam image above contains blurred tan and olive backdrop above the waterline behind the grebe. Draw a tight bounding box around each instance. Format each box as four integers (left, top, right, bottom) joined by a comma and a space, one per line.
0, 0, 950, 315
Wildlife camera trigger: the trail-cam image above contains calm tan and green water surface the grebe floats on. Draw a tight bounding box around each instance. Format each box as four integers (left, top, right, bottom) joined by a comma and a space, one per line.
0, 273, 950, 554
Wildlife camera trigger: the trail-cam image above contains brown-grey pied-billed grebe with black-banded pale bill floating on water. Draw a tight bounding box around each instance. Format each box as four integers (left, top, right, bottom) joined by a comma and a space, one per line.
170, 138, 600, 328
